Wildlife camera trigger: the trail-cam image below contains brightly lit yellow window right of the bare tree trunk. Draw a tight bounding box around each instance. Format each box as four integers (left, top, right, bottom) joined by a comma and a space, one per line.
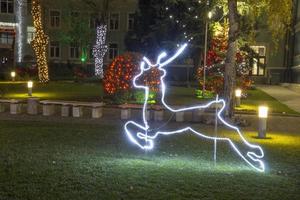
250, 46, 266, 76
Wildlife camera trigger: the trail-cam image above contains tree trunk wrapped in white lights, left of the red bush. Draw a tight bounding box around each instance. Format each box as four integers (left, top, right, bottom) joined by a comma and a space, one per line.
93, 24, 108, 78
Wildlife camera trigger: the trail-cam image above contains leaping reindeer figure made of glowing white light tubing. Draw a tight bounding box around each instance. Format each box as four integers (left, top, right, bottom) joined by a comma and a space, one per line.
124, 44, 265, 172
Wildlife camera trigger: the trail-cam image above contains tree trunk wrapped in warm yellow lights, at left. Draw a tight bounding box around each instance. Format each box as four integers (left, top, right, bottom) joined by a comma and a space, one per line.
31, 0, 49, 83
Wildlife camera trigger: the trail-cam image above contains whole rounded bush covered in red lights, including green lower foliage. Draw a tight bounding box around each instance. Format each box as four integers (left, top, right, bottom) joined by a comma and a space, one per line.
103, 52, 160, 103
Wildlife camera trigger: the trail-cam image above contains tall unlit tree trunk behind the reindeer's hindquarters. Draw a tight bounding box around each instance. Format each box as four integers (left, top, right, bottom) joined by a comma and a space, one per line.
224, 0, 239, 117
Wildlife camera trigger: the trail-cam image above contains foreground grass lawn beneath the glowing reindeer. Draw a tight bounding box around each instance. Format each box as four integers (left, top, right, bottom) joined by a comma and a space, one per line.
0, 121, 300, 200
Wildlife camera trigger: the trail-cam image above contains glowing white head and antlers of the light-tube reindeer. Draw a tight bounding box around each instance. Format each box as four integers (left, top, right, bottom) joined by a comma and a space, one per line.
133, 44, 187, 88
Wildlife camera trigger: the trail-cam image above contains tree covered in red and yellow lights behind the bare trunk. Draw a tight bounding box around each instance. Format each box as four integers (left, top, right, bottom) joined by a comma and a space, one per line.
196, 23, 253, 94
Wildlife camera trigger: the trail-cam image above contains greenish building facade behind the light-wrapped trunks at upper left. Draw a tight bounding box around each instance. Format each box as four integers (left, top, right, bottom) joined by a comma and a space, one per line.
0, 0, 137, 77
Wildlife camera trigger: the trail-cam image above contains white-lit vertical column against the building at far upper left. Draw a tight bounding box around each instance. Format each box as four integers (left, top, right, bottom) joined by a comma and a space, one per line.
15, 0, 27, 63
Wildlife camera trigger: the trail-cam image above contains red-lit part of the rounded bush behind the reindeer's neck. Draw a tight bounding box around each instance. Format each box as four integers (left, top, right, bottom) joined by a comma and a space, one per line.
103, 53, 160, 95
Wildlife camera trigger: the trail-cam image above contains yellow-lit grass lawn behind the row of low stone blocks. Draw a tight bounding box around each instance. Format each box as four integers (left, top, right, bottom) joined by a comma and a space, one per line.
0, 82, 298, 114
